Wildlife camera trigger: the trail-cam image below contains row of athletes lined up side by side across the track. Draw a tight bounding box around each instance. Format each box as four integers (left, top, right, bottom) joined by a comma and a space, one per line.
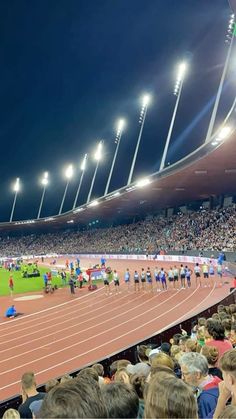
103, 263, 223, 294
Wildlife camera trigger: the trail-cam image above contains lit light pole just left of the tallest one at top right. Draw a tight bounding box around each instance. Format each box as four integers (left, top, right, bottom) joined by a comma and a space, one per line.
159, 62, 187, 170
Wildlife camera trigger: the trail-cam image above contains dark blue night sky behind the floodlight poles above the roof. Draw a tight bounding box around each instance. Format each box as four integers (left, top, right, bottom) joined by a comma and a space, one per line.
0, 0, 233, 221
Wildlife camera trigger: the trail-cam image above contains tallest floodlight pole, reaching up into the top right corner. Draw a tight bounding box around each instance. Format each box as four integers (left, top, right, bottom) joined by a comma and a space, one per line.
205, 15, 236, 143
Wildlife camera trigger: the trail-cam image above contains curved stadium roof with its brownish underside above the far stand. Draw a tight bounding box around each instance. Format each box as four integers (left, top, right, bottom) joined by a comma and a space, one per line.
0, 118, 236, 232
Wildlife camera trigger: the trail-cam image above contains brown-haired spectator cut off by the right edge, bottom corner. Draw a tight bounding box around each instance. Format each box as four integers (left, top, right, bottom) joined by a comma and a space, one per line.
214, 349, 236, 419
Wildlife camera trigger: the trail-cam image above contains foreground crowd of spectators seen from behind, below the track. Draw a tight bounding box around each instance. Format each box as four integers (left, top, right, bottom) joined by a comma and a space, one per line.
3, 304, 236, 419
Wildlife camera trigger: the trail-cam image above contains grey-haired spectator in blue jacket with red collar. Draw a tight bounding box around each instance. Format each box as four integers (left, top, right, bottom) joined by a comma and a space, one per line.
180, 352, 221, 418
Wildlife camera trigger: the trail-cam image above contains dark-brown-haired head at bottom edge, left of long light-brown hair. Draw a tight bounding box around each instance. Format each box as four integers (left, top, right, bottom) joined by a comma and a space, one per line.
101, 382, 139, 418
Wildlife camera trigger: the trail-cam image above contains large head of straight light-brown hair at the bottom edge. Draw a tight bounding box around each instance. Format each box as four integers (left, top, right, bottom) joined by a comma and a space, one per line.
144, 373, 198, 419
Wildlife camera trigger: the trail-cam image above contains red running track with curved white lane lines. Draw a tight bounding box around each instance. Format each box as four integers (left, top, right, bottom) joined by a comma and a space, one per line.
0, 261, 229, 399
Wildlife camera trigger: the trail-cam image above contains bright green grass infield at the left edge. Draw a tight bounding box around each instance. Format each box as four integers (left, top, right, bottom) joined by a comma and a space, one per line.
0, 268, 63, 296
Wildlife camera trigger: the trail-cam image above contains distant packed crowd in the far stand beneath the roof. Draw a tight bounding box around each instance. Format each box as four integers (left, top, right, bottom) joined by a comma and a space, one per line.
0, 207, 236, 257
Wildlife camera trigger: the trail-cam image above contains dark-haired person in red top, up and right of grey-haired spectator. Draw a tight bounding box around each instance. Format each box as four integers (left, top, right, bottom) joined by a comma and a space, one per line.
206, 319, 233, 366
